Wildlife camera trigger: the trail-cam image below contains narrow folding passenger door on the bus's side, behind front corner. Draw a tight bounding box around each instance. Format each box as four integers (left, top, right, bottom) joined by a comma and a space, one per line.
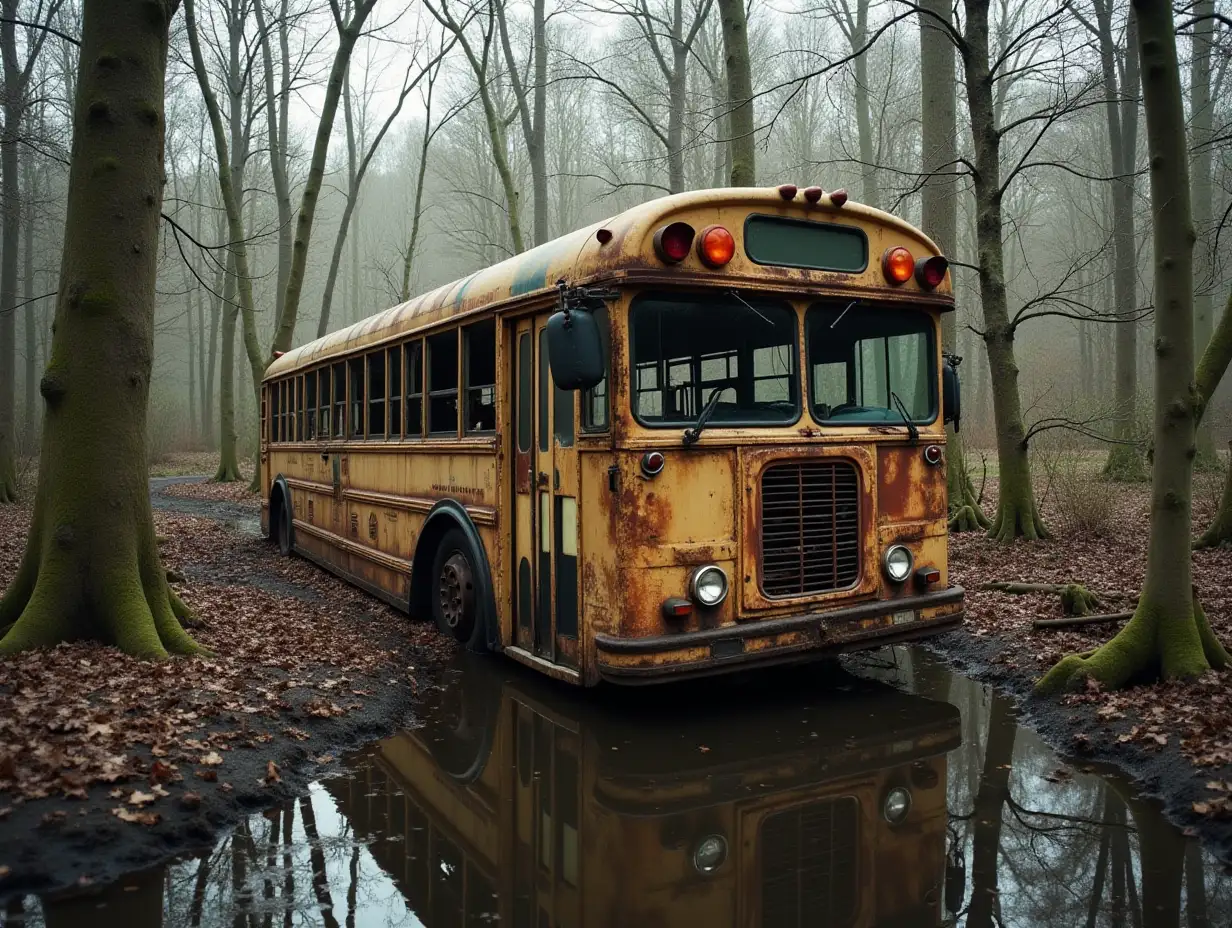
511, 314, 579, 668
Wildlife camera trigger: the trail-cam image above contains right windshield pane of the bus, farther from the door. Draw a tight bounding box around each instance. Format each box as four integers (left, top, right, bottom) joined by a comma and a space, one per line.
804, 302, 936, 425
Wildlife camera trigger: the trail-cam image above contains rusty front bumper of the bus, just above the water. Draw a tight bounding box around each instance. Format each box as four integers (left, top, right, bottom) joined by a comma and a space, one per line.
595, 587, 963, 683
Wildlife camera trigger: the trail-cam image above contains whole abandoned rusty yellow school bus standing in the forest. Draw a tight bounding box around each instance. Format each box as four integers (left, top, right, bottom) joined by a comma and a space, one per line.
260, 186, 962, 684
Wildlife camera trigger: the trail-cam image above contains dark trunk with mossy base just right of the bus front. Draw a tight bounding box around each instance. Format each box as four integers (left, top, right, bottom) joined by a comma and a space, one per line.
962, 0, 1047, 541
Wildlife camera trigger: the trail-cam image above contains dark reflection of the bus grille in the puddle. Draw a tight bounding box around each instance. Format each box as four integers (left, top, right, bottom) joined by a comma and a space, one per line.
760, 797, 860, 928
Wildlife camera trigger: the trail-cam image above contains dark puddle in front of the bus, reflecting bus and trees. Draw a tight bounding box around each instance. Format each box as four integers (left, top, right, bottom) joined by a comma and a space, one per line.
0, 649, 1232, 928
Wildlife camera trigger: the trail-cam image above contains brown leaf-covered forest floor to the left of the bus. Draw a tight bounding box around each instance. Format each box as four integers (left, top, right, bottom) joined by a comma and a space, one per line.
0, 466, 455, 900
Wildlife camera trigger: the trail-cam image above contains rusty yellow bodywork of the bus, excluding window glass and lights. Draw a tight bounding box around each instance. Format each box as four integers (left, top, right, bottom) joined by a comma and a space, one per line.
260, 189, 962, 684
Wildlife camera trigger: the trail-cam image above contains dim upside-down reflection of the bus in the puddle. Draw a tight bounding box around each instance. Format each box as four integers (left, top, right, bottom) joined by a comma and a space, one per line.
326, 667, 960, 928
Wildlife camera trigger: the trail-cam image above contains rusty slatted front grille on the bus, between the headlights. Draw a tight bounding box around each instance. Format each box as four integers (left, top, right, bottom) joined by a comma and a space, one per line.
761, 461, 860, 596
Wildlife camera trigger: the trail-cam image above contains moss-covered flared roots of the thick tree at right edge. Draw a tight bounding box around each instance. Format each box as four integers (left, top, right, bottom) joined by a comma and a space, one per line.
1035, 596, 1228, 695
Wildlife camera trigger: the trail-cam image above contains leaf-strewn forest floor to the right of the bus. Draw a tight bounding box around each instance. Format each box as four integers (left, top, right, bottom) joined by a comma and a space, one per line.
926, 455, 1232, 860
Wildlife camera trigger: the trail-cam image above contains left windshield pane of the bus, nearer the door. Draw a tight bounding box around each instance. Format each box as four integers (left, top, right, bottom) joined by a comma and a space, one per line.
630, 293, 800, 428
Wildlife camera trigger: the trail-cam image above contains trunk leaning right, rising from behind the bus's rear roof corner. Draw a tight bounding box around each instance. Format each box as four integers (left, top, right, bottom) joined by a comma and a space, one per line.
272, 0, 376, 354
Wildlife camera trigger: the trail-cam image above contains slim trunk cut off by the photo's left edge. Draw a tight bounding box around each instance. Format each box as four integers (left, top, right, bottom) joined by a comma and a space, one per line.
0, 0, 26, 502
